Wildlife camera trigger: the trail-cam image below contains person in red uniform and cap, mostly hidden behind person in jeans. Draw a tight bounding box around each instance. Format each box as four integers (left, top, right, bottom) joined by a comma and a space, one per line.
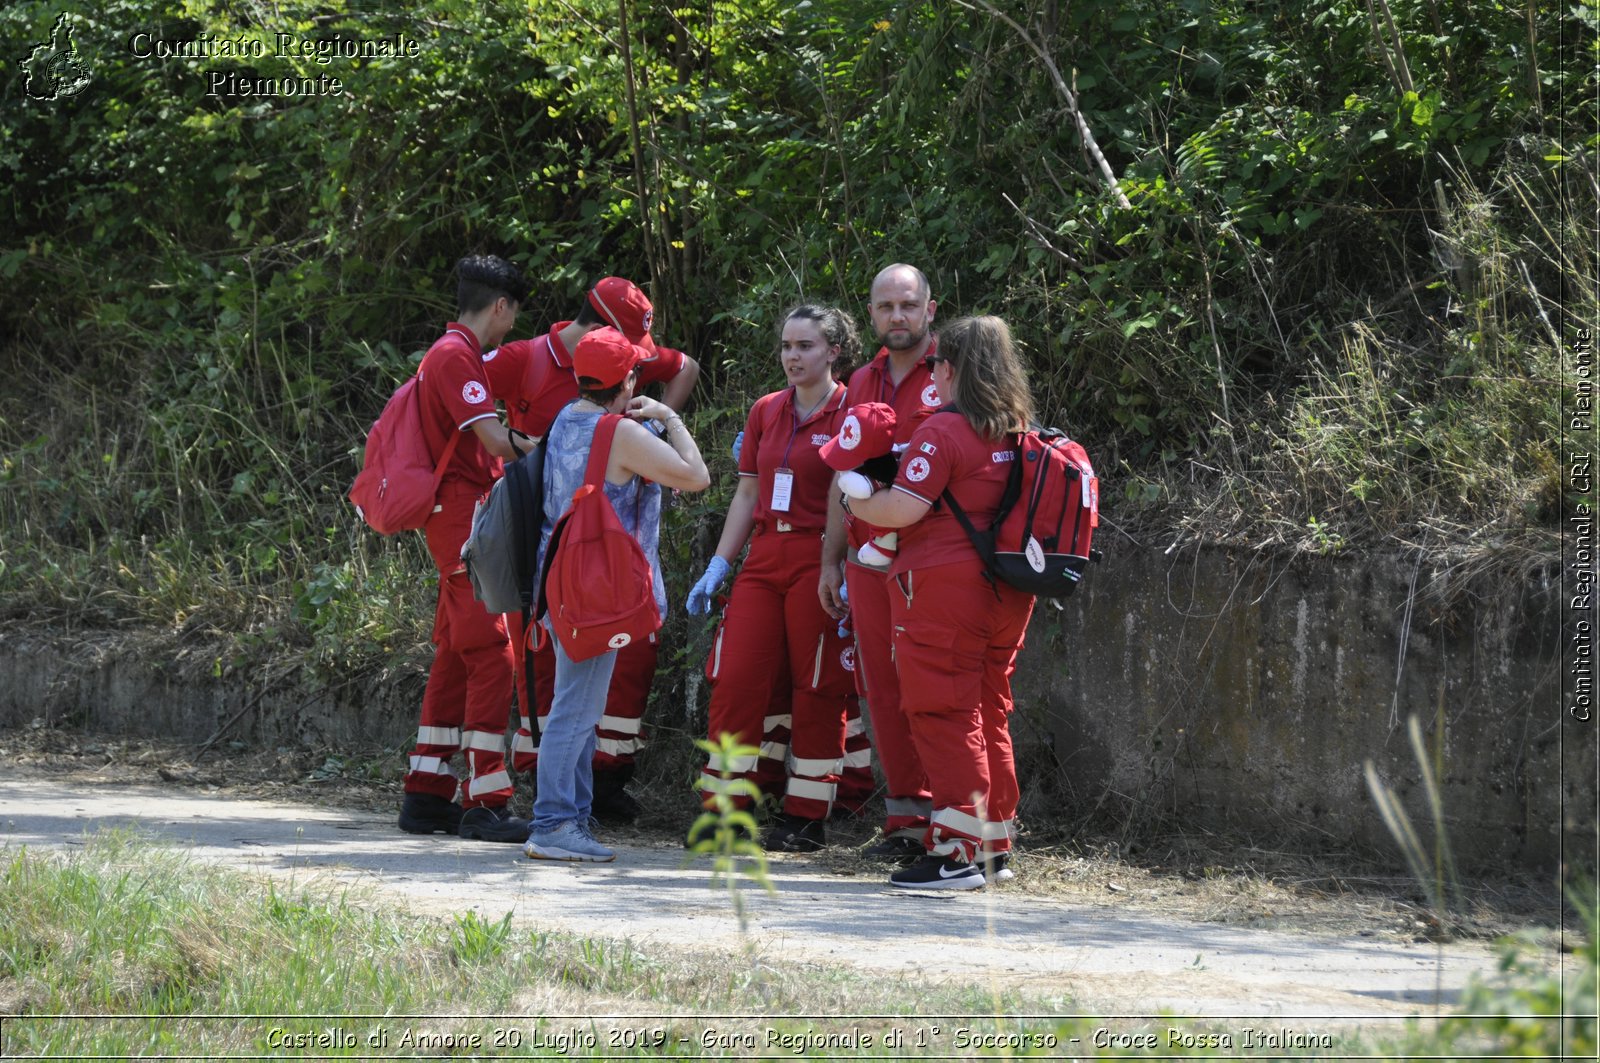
483, 277, 699, 821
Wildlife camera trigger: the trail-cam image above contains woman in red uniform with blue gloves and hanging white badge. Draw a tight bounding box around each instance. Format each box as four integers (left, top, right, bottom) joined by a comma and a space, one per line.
688, 304, 861, 852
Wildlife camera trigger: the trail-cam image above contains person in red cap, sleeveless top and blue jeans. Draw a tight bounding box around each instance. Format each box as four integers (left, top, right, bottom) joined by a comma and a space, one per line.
525, 327, 710, 861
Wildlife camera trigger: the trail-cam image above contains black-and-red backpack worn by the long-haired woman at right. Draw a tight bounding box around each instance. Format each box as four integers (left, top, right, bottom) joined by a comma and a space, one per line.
944, 427, 1099, 597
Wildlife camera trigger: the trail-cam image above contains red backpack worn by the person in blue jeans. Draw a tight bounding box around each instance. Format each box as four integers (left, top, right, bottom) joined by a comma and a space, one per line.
534, 413, 661, 661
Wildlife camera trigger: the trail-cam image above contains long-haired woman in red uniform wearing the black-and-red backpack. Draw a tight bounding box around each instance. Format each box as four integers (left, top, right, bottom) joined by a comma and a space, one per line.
846, 317, 1034, 890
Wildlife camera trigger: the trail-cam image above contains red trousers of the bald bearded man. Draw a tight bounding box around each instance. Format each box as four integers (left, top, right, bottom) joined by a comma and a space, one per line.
845, 562, 933, 834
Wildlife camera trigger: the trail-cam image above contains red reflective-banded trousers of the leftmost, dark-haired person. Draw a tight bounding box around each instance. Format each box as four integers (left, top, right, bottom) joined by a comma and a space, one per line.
403, 480, 512, 808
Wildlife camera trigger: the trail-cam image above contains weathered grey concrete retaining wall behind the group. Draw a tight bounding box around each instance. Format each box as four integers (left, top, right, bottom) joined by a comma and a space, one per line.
0, 535, 1595, 868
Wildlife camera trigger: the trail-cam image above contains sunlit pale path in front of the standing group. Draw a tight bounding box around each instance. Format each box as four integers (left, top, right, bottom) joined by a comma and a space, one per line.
0, 767, 1536, 1028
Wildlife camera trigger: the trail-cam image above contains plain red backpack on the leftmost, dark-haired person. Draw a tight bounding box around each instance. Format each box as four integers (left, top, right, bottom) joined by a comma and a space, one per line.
349, 376, 461, 535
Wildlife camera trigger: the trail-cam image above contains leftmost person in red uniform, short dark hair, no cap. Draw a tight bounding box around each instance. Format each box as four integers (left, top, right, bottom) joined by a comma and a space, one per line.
400, 255, 528, 842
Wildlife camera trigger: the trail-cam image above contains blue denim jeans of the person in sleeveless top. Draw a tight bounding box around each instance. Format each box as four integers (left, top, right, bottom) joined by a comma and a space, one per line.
533, 620, 616, 834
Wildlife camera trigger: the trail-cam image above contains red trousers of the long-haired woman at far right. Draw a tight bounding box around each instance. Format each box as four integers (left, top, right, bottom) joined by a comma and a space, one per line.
896, 557, 1034, 860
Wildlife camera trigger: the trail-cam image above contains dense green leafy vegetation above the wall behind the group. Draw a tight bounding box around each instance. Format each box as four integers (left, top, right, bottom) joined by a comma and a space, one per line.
0, 0, 1600, 679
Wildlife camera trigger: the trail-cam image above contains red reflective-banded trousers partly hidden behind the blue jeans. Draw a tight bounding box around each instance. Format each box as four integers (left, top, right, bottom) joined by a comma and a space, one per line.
506, 613, 656, 775
